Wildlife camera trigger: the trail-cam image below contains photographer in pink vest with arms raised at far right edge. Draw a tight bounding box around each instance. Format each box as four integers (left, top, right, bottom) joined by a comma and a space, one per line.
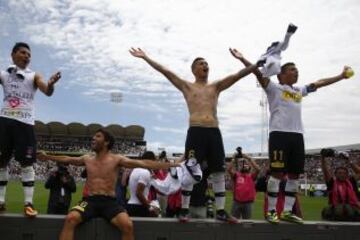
320, 148, 360, 221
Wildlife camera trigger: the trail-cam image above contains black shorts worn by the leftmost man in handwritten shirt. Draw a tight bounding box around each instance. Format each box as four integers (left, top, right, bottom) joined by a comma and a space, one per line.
0, 117, 36, 166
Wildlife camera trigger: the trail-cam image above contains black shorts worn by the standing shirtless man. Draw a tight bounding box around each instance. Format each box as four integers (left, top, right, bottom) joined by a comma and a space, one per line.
185, 127, 225, 173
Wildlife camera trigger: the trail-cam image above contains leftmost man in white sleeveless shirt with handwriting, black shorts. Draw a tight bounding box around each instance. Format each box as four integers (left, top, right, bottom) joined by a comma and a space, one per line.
0, 42, 61, 217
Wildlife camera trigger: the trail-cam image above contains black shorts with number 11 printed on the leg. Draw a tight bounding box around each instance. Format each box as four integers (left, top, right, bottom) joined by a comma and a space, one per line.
269, 132, 305, 174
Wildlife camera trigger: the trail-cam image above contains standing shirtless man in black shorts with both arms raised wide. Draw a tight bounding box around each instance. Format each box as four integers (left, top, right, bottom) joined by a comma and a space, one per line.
130, 48, 257, 223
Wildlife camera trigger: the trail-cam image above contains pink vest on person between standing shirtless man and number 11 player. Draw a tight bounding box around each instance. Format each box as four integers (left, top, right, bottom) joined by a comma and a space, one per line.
234, 172, 256, 202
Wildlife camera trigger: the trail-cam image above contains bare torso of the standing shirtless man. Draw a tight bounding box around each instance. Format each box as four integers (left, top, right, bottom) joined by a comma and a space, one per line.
183, 82, 219, 127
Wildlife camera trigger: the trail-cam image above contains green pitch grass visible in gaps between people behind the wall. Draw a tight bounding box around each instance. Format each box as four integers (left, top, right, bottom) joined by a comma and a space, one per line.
6, 181, 327, 220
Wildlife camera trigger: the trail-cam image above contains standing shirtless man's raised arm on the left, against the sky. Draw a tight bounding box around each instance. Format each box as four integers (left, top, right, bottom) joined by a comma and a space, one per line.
129, 48, 187, 91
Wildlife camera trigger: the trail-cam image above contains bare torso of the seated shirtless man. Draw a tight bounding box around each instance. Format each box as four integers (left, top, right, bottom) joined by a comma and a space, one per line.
84, 153, 120, 196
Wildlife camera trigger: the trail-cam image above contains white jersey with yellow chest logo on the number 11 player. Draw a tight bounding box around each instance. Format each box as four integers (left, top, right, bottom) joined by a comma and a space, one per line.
265, 81, 308, 134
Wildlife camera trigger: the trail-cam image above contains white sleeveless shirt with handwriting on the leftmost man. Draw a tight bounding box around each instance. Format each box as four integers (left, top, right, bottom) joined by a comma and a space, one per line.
0, 65, 36, 125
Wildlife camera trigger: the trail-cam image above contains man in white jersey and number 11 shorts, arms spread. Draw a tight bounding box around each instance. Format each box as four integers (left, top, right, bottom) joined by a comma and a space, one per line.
230, 49, 350, 223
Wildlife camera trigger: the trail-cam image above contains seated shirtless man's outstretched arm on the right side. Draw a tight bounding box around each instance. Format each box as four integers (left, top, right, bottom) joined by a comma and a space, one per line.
118, 155, 179, 169
